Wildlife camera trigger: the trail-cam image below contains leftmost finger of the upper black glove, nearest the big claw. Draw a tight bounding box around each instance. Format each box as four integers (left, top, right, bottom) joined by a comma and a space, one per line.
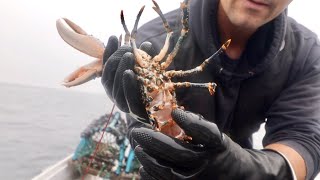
101, 46, 132, 101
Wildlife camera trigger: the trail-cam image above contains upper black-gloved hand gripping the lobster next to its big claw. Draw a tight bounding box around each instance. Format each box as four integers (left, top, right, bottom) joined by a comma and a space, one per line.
101, 36, 154, 123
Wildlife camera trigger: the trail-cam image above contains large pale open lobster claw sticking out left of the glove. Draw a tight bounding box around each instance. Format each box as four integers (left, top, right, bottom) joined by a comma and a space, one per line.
56, 18, 105, 87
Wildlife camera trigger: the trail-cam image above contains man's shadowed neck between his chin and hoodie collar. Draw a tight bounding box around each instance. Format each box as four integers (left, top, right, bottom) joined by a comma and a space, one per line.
218, 4, 256, 59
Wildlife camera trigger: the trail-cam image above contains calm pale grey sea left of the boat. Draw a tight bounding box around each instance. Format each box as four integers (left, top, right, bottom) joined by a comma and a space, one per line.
0, 83, 112, 180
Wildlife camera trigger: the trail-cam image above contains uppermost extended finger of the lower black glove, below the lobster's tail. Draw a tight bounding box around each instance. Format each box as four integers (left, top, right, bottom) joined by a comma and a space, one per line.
131, 128, 206, 167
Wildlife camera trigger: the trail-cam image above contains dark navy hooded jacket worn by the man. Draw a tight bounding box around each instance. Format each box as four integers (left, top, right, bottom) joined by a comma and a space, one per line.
128, 0, 320, 179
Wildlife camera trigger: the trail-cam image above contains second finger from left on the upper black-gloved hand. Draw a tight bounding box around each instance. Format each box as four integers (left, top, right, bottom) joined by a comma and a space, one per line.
112, 52, 135, 112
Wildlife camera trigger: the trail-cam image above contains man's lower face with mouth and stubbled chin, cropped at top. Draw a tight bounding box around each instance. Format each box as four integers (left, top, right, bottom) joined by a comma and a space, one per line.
220, 0, 292, 29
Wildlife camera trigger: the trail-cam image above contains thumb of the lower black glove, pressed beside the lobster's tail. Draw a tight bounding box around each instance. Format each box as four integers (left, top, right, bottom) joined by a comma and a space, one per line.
171, 109, 223, 148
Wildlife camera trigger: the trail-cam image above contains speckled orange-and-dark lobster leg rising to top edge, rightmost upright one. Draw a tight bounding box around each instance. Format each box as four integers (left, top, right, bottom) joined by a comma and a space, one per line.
161, 0, 189, 69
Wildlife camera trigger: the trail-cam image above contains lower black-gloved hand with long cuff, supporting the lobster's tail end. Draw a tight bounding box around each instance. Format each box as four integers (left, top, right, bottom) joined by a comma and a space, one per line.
132, 109, 292, 180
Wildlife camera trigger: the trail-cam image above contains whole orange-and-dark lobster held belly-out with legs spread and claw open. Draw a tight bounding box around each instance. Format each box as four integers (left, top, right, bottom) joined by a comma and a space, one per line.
57, 0, 231, 140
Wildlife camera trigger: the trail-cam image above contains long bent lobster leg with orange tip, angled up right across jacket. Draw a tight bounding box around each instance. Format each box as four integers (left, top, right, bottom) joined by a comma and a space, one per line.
166, 40, 231, 77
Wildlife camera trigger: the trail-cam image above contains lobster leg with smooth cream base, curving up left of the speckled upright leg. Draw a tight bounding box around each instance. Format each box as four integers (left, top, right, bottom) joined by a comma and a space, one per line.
152, 0, 173, 62
